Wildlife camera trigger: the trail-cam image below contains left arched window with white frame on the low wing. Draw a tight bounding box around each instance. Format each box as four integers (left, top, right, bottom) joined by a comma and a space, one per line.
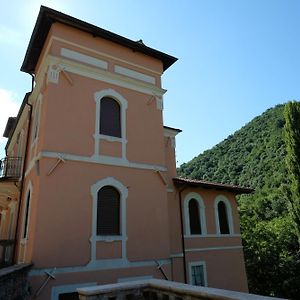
184, 192, 206, 235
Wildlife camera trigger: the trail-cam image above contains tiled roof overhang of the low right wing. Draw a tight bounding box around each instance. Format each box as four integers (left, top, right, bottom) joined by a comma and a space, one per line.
173, 177, 254, 195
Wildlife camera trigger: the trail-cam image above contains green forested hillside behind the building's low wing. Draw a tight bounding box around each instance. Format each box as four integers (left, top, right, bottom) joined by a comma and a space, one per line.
178, 105, 300, 299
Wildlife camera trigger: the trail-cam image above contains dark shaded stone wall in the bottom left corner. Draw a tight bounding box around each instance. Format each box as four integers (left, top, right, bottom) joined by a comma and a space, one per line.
0, 264, 31, 300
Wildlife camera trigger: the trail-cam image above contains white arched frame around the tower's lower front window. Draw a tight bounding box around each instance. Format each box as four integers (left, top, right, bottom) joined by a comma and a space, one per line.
90, 177, 128, 261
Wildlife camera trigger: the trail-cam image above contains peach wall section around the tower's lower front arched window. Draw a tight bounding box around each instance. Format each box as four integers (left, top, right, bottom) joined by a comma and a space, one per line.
28, 159, 169, 268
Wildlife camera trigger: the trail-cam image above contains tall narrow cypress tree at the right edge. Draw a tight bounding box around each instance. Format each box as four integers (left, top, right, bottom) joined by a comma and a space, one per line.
284, 101, 300, 245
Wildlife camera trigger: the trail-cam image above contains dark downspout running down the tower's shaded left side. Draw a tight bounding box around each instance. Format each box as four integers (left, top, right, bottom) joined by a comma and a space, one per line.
13, 73, 34, 263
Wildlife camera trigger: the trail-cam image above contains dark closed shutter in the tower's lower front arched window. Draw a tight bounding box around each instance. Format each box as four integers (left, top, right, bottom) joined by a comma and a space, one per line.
97, 186, 120, 235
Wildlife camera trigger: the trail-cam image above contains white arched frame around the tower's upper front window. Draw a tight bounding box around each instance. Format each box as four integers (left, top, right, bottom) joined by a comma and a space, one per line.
94, 89, 128, 160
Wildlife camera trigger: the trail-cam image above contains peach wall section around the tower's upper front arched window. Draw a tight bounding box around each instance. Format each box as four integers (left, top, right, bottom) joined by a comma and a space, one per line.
43, 74, 164, 165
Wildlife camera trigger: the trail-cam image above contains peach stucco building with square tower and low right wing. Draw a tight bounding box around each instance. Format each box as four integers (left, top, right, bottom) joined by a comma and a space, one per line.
0, 7, 251, 300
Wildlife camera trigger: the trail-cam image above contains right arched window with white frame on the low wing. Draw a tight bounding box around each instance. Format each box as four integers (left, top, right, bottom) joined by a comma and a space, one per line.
215, 196, 233, 234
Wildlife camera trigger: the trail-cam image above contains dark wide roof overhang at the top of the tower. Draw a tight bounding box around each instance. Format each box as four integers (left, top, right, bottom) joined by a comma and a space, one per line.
21, 6, 177, 74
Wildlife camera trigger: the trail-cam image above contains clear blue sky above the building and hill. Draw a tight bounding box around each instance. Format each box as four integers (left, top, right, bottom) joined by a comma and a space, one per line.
0, 0, 300, 165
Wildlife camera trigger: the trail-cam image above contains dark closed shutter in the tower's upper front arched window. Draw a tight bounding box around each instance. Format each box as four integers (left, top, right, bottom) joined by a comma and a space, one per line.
100, 97, 121, 137
